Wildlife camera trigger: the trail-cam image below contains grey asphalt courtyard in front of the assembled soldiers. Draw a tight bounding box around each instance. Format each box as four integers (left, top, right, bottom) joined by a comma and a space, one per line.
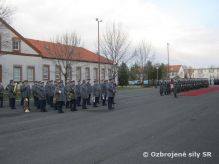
0, 88, 219, 164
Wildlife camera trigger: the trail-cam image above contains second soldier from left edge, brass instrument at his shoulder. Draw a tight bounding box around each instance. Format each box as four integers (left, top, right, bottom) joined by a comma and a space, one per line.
6, 80, 18, 109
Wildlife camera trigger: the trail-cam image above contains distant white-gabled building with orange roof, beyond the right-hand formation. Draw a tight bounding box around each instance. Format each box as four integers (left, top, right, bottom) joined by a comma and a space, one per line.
169, 65, 185, 78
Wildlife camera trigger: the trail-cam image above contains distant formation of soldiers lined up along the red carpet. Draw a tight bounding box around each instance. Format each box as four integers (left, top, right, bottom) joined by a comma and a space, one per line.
159, 79, 209, 98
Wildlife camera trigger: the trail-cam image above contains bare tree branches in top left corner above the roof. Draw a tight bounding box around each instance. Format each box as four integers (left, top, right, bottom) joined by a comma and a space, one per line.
0, 0, 14, 22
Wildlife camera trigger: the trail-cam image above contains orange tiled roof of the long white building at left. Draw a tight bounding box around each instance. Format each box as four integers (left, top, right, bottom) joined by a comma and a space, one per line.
26, 38, 112, 64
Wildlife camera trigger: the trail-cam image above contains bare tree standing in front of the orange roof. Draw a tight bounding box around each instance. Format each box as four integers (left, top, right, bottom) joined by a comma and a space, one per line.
46, 33, 81, 83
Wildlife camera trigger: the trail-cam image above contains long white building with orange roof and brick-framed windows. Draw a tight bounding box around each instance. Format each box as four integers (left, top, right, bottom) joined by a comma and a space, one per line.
0, 18, 112, 86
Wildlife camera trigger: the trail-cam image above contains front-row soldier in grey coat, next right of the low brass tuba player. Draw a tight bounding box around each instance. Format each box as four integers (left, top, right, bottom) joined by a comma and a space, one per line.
38, 82, 46, 112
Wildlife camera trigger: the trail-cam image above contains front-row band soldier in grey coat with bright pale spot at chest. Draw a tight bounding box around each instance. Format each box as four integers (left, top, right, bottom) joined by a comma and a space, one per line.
54, 81, 65, 113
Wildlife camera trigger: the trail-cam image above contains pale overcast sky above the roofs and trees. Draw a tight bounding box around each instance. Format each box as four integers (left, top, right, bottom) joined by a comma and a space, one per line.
7, 0, 219, 68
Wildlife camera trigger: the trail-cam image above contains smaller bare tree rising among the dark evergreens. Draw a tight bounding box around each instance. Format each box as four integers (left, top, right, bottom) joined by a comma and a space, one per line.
134, 41, 155, 84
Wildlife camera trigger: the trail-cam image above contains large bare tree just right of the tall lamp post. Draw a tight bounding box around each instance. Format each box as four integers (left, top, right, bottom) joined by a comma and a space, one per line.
100, 22, 130, 79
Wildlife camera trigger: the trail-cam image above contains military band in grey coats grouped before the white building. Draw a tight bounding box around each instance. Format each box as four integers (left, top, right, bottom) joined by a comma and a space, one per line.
0, 79, 116, 113
